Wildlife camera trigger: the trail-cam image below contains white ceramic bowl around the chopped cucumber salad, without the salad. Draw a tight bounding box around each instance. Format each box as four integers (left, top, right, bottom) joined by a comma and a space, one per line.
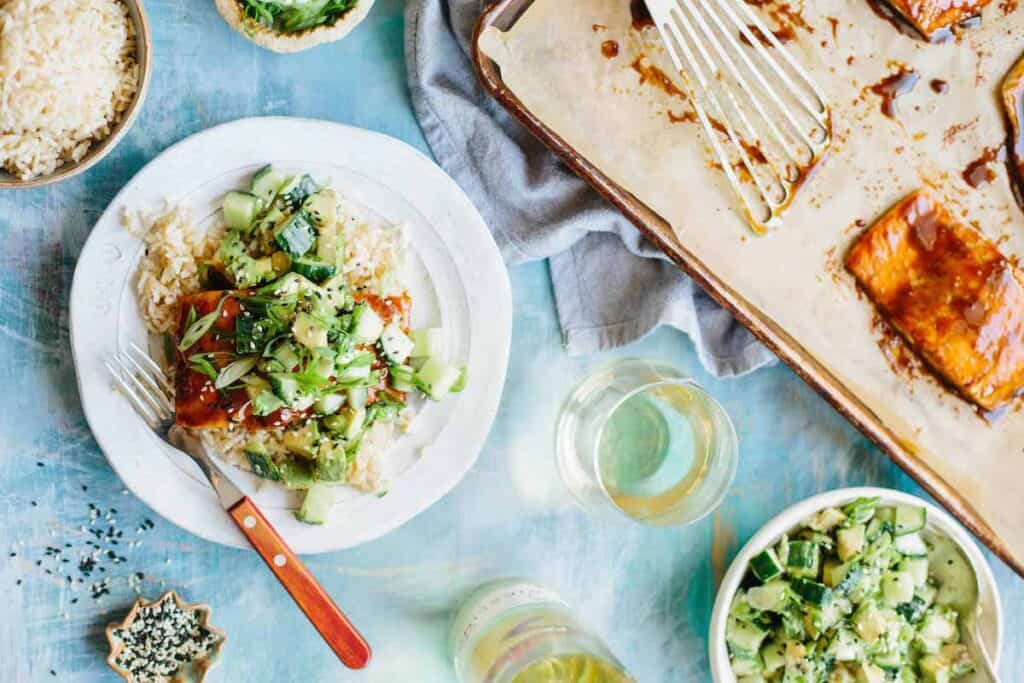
708, 487, 1002, 683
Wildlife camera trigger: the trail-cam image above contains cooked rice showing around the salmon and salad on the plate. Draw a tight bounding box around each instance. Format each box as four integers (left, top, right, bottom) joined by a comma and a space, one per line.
130, 189, 413, 492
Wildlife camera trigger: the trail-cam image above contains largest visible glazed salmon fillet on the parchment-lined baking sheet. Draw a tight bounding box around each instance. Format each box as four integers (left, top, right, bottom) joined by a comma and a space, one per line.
846, 191, 1024, 411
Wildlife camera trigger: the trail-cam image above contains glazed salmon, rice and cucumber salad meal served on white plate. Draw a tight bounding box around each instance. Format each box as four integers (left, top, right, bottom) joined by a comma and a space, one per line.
124, 166, 465, 523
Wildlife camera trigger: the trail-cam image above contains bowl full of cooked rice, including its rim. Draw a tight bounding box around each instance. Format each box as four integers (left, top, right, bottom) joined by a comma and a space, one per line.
0, 0, 151, 188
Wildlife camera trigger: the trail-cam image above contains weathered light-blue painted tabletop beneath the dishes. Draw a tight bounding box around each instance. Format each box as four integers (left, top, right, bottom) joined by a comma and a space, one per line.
0, 0, 1024, 683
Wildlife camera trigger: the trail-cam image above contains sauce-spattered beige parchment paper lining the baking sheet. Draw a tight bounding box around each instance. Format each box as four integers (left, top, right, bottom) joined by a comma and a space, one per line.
479, 0, 1024, 568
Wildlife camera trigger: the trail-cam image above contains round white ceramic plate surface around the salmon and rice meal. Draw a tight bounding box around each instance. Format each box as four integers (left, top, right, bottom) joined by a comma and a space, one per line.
71, 118, 512, 553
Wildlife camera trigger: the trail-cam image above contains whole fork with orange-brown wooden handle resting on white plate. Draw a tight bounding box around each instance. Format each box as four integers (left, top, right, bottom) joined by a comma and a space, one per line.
104, 343, 371, 669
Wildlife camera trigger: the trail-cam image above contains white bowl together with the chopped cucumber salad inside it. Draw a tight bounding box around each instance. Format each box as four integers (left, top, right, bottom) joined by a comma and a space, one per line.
711, 488, 1001, 683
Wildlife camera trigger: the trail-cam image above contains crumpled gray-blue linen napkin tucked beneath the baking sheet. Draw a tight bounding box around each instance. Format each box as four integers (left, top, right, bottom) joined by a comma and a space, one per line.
406, 0, 774, 376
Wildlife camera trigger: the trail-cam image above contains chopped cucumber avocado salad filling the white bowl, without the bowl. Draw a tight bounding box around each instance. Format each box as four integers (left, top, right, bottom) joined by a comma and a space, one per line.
726, 499, 975, 683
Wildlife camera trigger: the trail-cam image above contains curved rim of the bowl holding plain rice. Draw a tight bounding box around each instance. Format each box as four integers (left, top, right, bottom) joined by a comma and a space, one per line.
0, 0, 153, 190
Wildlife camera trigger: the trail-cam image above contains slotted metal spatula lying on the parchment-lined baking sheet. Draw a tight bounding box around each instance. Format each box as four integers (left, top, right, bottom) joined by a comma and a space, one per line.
646, 0, 833, 232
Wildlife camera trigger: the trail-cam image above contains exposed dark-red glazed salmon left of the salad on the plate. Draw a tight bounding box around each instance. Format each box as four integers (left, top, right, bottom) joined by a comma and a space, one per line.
174, 292, 308, 430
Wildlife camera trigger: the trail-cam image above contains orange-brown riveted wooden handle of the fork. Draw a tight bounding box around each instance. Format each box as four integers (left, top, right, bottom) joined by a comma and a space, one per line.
227, 497, 370, 669
